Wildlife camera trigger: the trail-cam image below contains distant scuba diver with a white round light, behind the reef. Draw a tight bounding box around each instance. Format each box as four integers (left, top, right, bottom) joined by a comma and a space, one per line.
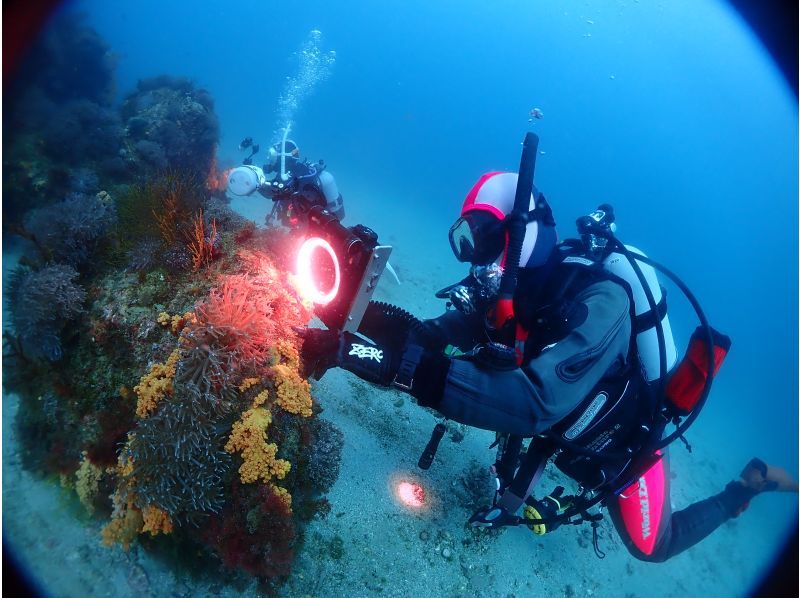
228, 127, 344, 227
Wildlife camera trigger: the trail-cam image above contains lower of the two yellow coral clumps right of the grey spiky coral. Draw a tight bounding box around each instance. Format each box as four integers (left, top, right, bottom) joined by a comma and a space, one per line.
225, 407, 291, 484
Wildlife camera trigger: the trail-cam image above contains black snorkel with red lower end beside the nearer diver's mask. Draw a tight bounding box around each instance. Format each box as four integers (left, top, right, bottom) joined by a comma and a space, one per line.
494, 133, 539, 329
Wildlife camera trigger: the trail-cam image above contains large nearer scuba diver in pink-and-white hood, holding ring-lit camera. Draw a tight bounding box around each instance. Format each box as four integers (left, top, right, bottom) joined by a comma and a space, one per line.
300, 134, 798, 562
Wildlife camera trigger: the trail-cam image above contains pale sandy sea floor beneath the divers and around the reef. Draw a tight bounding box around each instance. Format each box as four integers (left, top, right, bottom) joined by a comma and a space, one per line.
2, 204, 789, 597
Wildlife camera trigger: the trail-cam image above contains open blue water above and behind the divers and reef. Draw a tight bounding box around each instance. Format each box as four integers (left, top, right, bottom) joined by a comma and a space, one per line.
7, 0, 798, 596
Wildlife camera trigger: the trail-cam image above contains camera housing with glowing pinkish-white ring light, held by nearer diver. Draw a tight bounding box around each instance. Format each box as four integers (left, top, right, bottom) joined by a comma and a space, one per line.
297, 206, 392, 333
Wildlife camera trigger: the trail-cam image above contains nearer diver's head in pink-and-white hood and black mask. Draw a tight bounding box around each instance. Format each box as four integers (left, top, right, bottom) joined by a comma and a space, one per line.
450, 172, 558, 268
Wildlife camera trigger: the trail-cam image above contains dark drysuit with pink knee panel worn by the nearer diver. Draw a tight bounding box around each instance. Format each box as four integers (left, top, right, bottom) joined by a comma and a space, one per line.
338, 252, 755, 561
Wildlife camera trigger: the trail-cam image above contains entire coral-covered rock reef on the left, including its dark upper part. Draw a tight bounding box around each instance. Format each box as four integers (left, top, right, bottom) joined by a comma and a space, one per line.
3, 15, 341, 588
